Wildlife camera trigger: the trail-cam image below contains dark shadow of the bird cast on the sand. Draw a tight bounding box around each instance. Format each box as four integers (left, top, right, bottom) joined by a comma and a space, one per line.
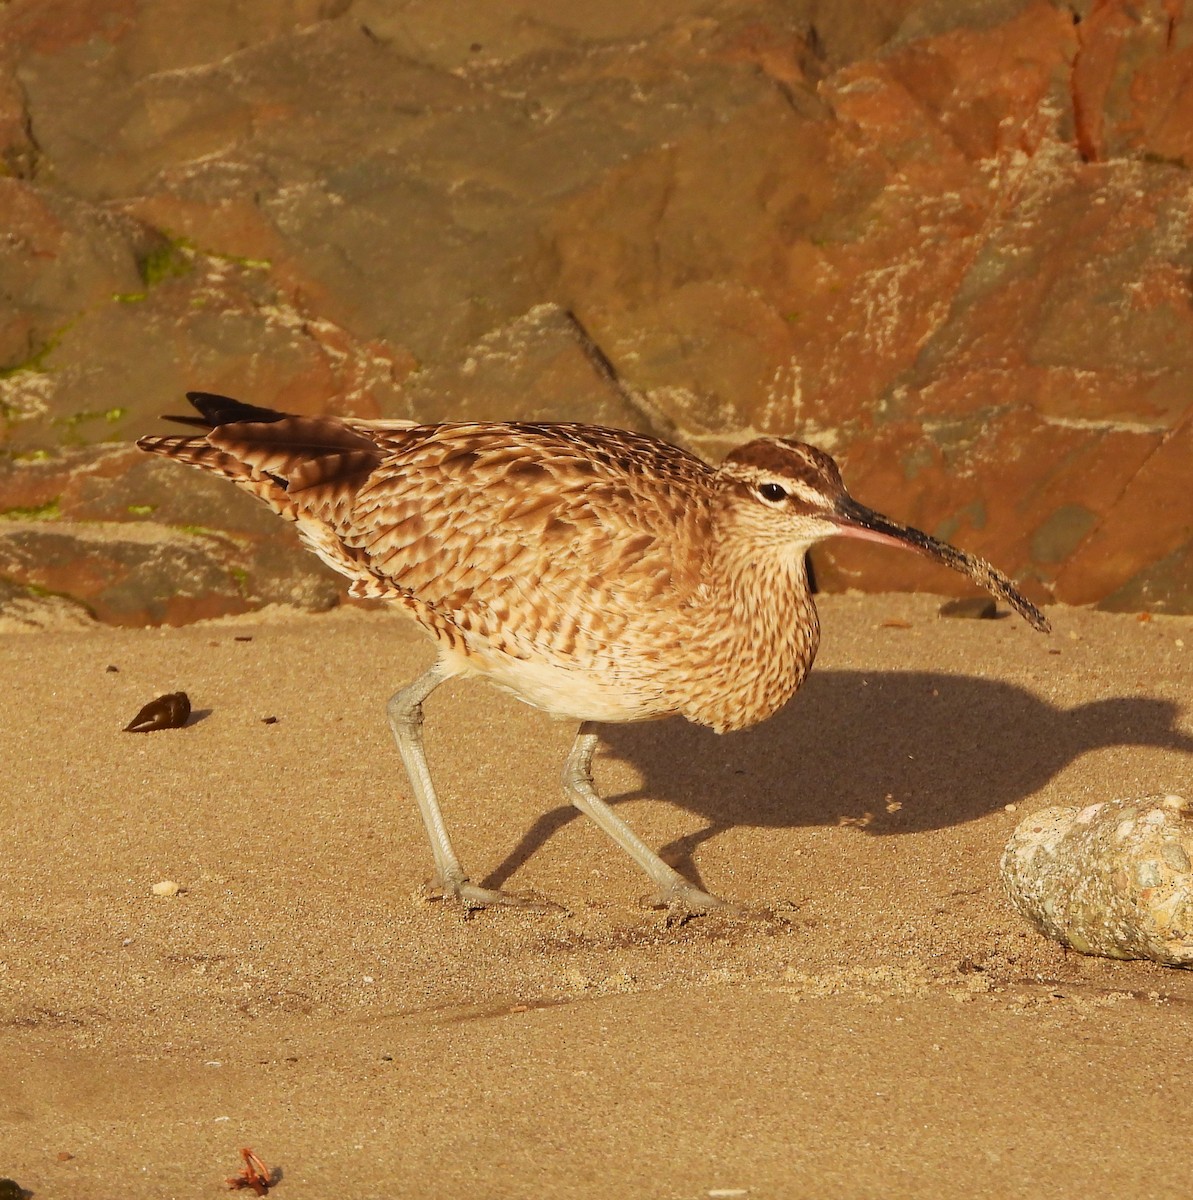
485, 670, 1193, 887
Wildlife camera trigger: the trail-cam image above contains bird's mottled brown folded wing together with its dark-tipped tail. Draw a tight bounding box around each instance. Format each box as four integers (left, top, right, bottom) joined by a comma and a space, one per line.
139, 392, 712, 664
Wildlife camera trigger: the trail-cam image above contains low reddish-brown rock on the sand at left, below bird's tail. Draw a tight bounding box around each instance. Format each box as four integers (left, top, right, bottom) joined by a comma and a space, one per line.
0, 446, 344, 625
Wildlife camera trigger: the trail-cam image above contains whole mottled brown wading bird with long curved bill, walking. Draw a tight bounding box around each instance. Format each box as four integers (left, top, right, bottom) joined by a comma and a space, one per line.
138, 394, 1047, 908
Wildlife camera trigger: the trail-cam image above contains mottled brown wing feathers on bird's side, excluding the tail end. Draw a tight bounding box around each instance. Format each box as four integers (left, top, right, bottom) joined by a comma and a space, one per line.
336, 424, 712, 659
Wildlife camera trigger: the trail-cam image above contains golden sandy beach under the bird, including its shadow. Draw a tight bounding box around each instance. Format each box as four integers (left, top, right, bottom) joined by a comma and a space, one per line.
0, 595, 1193, 1200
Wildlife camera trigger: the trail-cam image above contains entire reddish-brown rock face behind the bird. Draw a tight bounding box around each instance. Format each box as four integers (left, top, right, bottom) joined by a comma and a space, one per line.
0, 0, 1193, 623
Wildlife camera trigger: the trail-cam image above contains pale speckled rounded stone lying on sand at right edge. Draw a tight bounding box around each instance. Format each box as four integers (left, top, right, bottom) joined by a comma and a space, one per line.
1002, 796, 1193, 967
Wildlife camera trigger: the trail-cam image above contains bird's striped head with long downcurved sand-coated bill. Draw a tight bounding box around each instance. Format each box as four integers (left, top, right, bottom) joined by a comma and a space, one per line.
718, 438, 1050, 632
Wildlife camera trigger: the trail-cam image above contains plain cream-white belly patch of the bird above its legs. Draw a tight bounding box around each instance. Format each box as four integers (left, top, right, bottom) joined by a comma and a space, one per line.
444, 650, 675, 722
